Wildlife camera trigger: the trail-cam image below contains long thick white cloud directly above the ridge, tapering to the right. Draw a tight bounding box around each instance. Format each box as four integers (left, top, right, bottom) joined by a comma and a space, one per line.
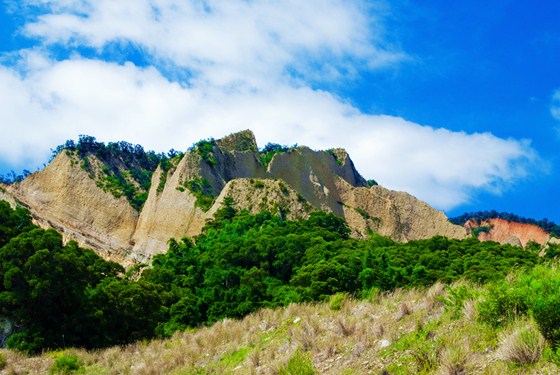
0, 59, 535, 212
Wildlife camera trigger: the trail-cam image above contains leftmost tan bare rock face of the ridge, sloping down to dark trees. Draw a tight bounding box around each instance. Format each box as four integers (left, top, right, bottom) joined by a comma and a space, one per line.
7, 152, 138, 264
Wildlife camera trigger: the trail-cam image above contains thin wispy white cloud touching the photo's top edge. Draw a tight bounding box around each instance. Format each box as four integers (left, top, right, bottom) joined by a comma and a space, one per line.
25, 0, 403, 87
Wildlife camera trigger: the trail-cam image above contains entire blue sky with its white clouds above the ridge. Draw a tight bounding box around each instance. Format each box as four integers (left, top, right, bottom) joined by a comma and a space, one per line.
0, 0, 560, 222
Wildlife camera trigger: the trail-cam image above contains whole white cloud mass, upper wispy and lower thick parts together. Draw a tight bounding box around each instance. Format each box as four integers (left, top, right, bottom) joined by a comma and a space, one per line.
0, 0, 538, 209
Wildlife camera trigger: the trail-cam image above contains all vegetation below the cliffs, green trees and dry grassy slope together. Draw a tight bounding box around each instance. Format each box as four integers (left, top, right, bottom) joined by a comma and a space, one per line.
0, 199, 560, 374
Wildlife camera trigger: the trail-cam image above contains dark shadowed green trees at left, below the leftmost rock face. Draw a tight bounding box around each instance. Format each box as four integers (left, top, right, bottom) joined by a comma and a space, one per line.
0, 203, 166, 353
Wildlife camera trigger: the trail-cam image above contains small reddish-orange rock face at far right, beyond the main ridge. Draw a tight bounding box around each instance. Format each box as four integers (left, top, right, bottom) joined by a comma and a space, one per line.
464, 219, 550, 247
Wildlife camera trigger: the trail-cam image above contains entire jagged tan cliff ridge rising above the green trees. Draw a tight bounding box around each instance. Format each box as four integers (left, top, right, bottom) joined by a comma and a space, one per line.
0, 131, 467, 266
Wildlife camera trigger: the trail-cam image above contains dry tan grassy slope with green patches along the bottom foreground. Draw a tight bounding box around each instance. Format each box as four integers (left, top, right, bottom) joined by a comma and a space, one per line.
0, 284, 560, 374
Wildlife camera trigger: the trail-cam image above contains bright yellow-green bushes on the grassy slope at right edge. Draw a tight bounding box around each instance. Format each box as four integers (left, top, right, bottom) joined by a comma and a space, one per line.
479, 266, 560, 346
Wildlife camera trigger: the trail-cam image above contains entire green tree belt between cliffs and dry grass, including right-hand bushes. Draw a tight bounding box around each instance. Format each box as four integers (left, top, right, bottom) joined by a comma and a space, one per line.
0, 199, 560, 353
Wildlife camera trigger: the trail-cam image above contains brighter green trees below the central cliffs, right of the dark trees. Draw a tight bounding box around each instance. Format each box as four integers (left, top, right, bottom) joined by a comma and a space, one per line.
142, 212, 539, 335
